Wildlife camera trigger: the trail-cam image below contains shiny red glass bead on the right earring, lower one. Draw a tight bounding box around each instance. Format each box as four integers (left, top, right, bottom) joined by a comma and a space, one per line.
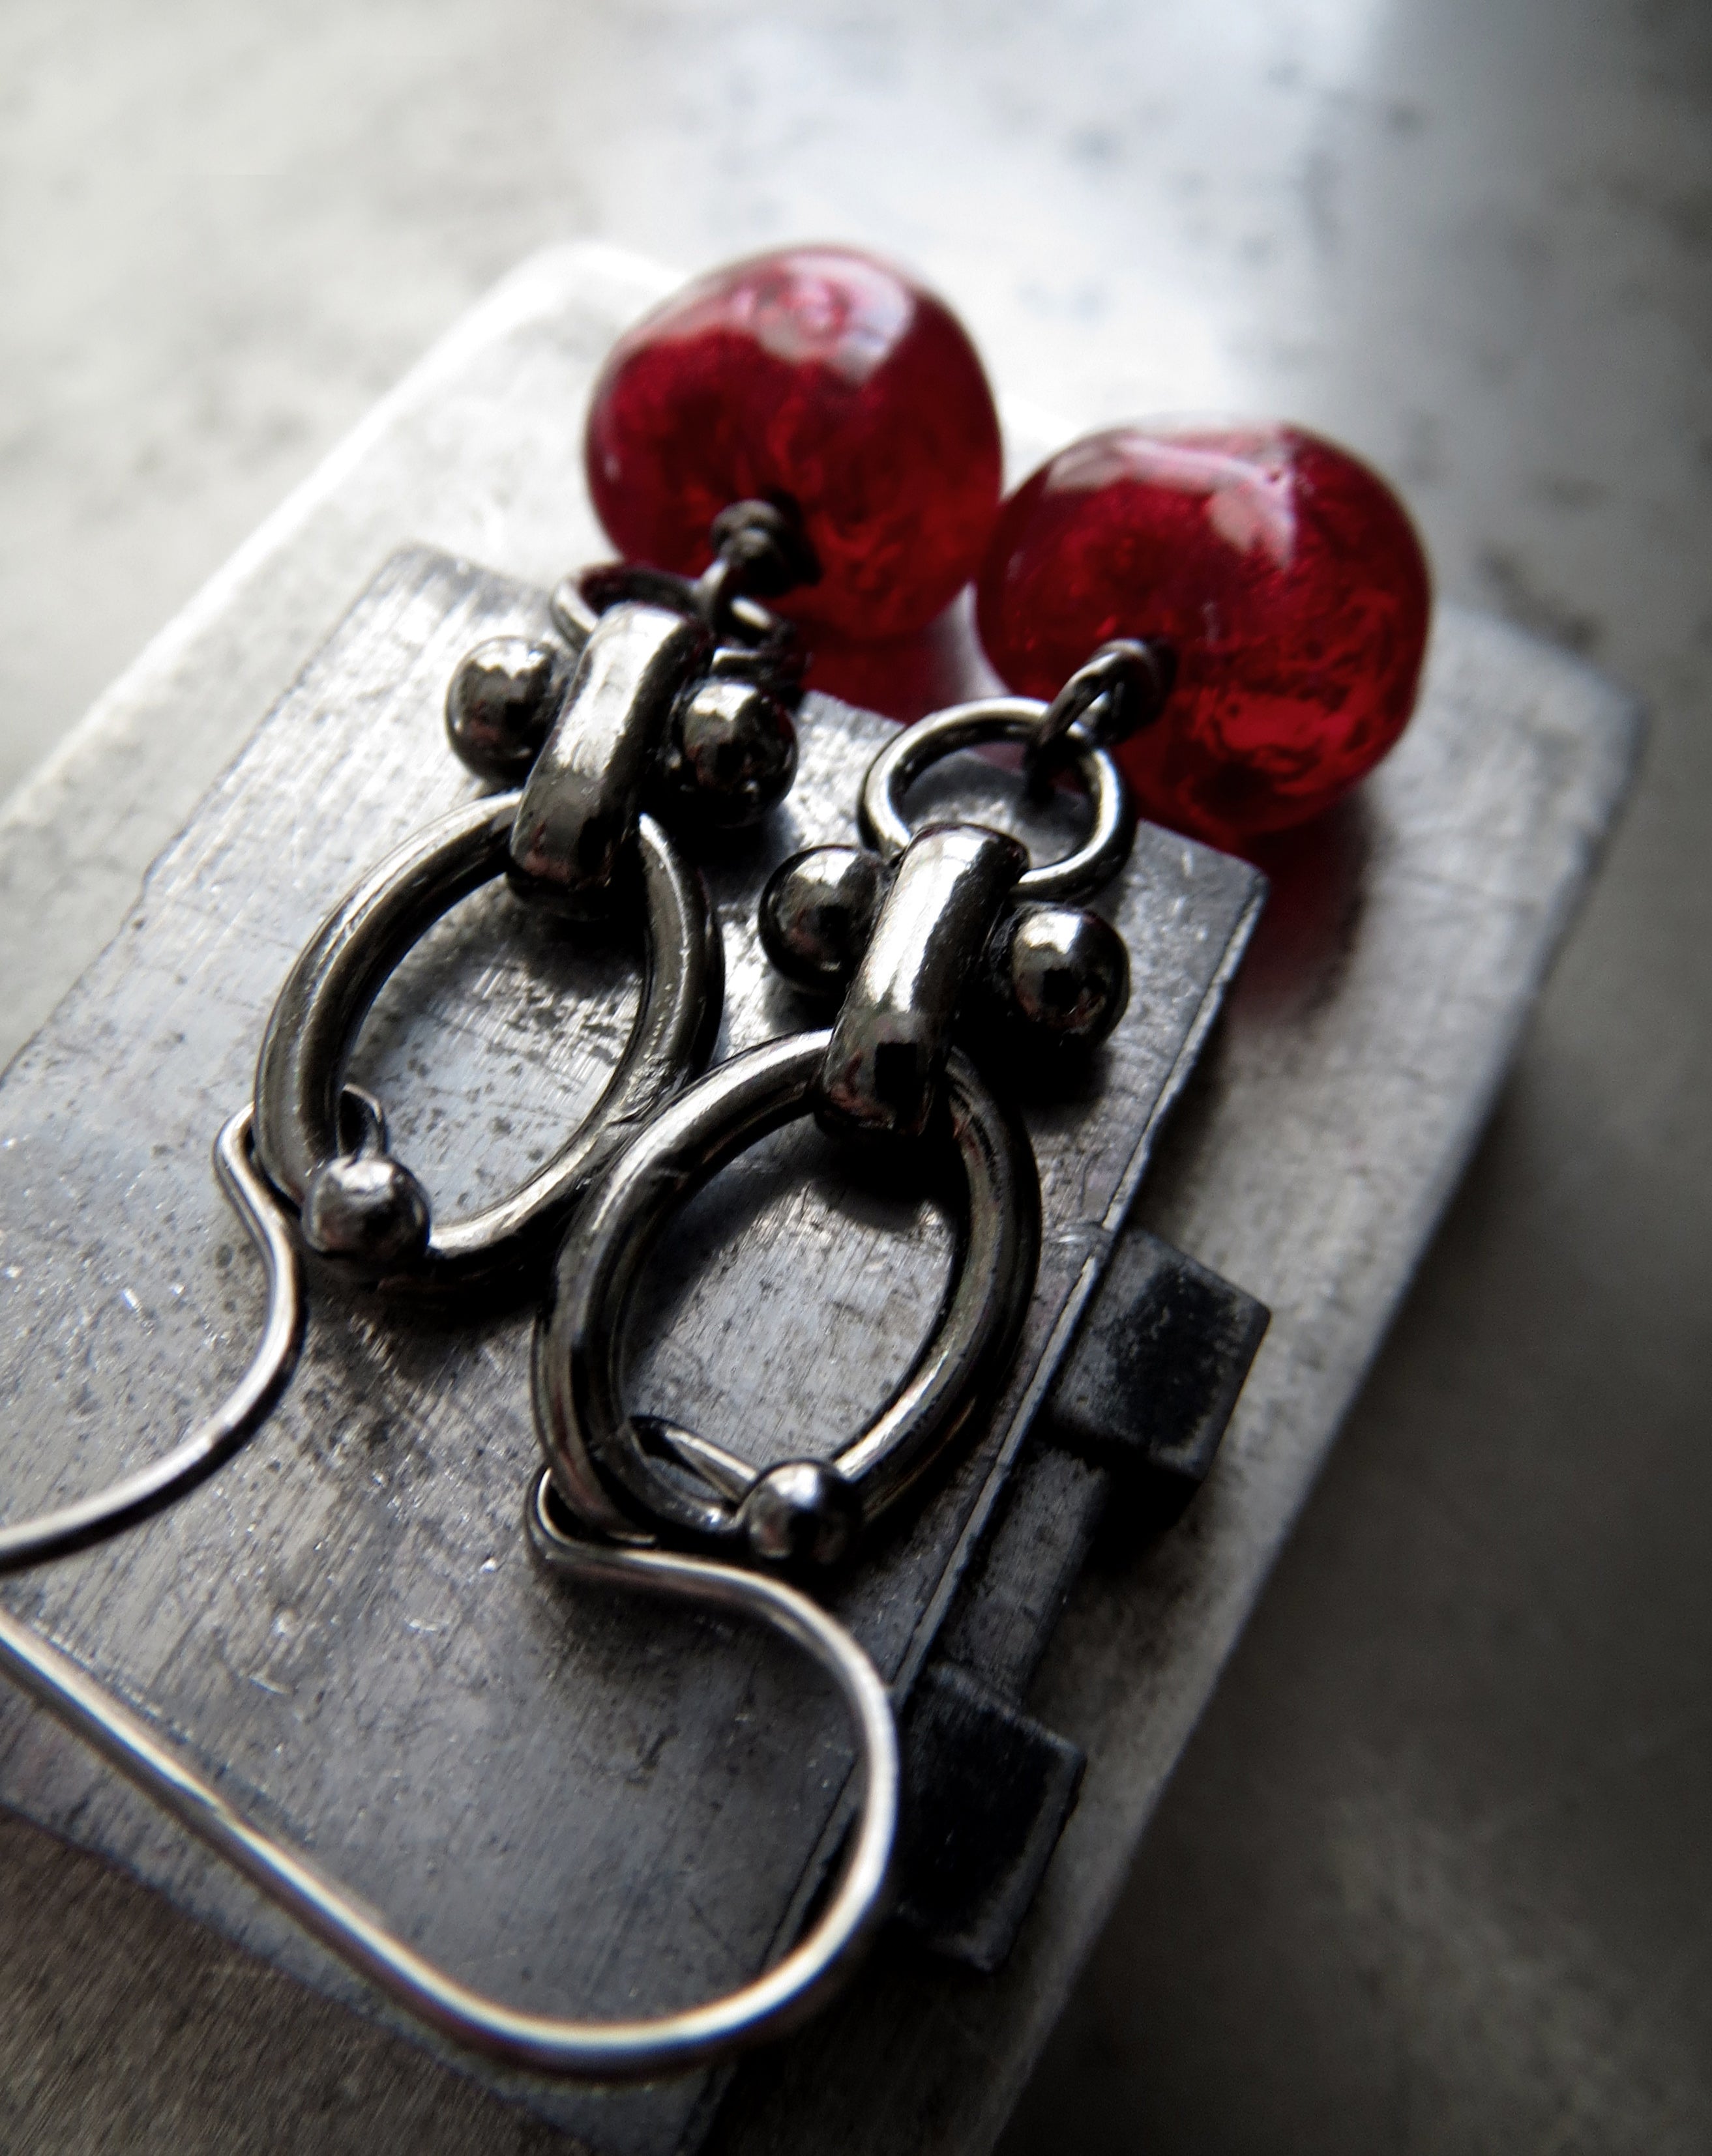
979, 427, 1432, 845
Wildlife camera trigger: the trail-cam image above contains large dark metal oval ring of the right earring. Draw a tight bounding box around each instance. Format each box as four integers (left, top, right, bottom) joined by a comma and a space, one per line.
535, 1030, 1039, 1546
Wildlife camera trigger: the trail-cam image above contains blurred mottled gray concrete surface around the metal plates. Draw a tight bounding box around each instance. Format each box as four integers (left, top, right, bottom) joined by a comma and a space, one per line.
0, 0, 1712, 2156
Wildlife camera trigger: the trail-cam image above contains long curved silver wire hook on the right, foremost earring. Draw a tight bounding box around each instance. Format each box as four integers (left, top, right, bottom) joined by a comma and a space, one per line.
0, 1475, 897, 2080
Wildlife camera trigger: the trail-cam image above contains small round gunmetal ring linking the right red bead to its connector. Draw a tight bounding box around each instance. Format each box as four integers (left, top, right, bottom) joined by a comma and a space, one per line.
861, 696, 1136, 901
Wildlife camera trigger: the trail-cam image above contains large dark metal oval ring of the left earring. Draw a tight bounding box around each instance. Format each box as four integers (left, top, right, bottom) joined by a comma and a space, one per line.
254, 791, 724, 1287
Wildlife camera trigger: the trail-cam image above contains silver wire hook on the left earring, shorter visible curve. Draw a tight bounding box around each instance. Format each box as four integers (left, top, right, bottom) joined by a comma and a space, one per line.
0, 1108, 304, 1572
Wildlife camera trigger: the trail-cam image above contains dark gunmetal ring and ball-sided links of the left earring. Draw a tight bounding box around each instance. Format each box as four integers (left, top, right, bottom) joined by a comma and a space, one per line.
257, 500, 819, 1287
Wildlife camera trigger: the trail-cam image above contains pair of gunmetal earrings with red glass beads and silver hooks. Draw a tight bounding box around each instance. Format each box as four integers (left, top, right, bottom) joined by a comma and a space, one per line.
0, 254, 1425, 2078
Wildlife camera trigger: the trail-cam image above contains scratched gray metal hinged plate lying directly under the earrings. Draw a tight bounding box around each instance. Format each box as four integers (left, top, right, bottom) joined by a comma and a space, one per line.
0, 552, 1259, 2151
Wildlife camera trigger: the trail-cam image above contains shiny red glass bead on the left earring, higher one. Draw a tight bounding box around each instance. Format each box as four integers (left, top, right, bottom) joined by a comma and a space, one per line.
584, 248, 1001, 636
